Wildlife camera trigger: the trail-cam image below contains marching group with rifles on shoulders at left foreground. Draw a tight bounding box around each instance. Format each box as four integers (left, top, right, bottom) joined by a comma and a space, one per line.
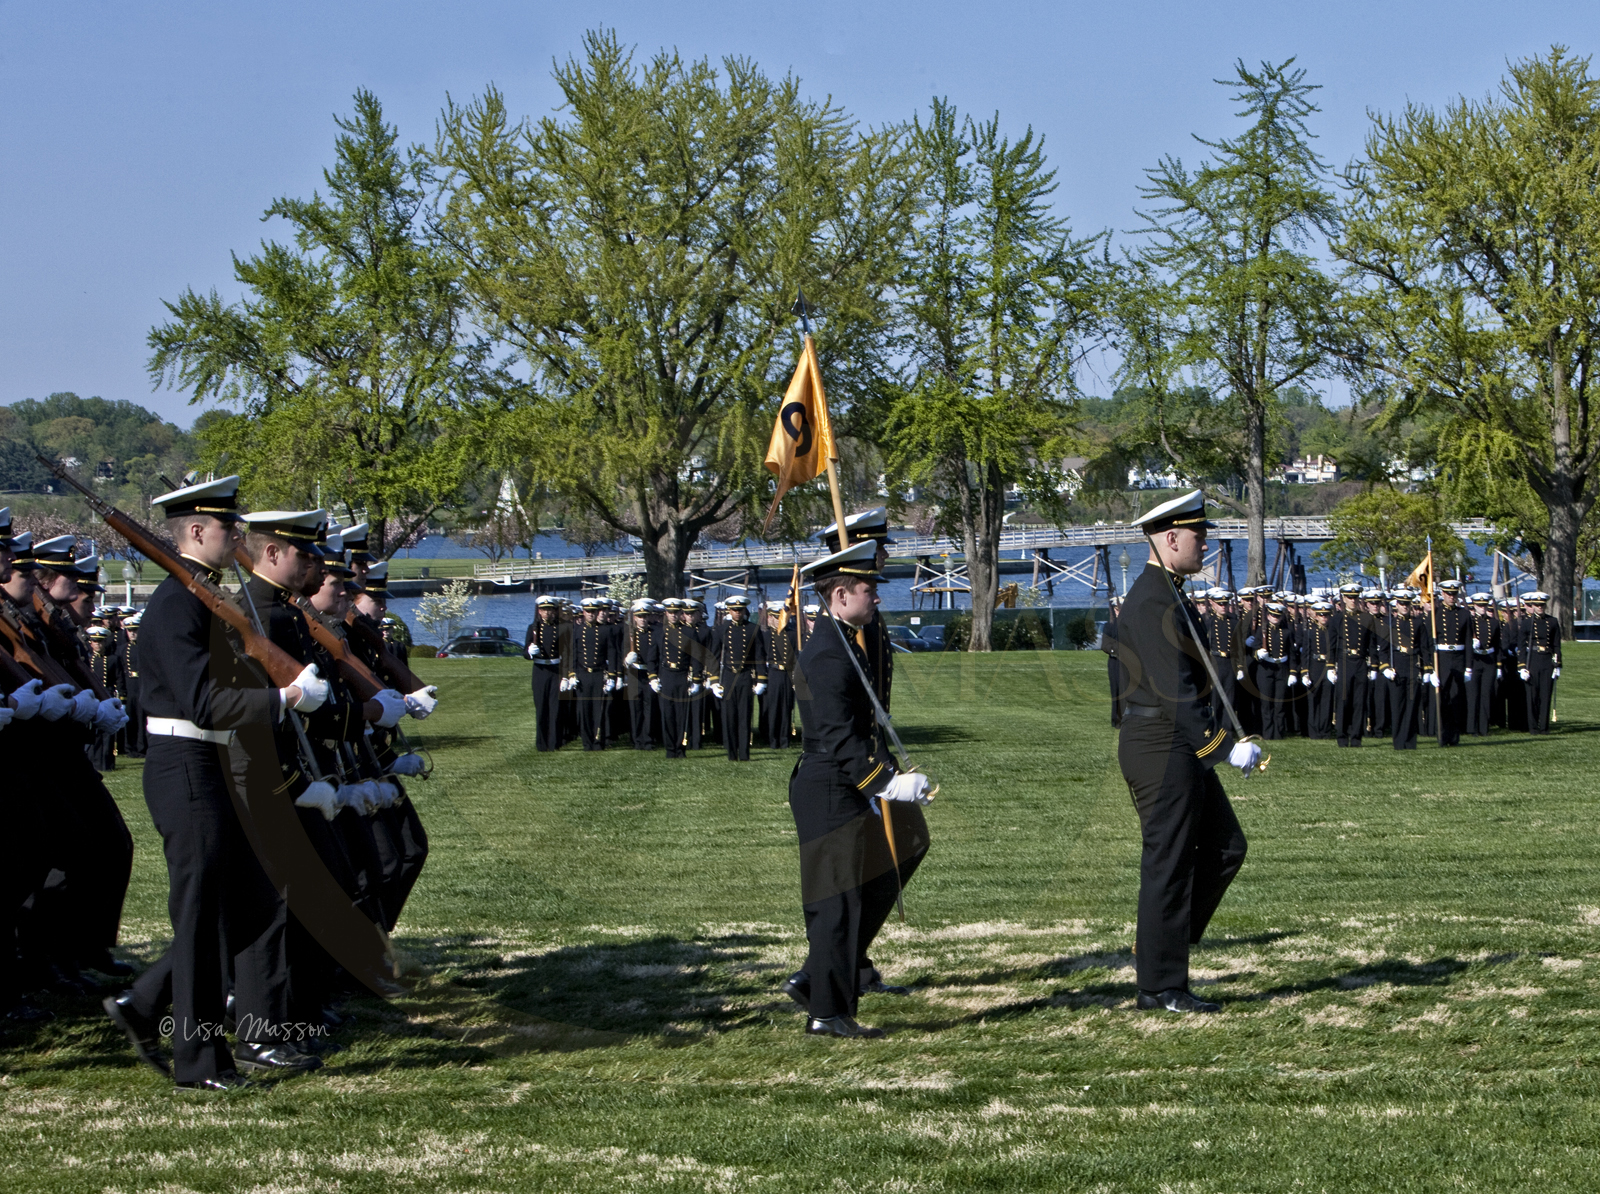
0, 477, 435, 1090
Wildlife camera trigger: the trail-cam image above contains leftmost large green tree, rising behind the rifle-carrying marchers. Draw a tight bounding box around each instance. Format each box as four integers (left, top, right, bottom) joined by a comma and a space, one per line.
149, 91, 512, 552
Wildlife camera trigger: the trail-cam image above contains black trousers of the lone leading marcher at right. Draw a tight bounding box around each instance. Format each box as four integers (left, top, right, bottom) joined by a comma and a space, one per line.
1117, 717, 1246, 991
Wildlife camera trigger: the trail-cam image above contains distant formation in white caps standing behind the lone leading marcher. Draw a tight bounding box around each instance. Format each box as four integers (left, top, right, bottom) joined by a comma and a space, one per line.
1145, 581, 1562, 751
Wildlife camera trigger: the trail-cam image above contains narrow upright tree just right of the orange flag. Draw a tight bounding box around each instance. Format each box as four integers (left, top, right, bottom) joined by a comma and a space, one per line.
885, 99, 1104, 651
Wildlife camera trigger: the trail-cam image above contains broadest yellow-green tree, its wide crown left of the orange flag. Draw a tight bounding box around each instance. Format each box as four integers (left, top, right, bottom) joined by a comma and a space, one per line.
437, 32, 915, 597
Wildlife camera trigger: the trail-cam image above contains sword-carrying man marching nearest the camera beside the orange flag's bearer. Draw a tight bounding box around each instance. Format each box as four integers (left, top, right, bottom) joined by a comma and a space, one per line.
784, 539, 930, 1037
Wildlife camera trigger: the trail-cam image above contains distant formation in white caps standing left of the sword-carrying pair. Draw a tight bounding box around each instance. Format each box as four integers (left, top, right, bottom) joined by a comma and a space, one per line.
523, 506, 921, 762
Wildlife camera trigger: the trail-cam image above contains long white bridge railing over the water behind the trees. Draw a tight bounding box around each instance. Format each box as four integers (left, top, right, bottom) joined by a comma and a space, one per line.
472, 515, 1491, 584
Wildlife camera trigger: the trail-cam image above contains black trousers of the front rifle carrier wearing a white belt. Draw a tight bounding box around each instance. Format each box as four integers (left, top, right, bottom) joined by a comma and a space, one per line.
133, 738, 288, 1082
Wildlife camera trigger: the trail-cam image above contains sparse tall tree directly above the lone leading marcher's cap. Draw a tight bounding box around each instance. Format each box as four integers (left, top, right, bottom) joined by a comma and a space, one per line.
1118, 59, 1338, 584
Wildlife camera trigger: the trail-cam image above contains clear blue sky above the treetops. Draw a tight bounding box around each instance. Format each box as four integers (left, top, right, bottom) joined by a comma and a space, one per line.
0, 0, 1600, 424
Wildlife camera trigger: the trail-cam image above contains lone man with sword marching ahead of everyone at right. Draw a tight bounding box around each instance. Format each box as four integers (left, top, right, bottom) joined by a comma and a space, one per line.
1117, 490, 1261, 1012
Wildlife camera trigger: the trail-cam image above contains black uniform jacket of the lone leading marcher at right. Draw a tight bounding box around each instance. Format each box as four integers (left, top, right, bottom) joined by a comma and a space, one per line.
1117, 563, 1232, 767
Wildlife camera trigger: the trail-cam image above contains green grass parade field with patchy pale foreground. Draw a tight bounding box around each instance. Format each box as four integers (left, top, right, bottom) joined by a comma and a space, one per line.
0, 647, 1600, 1194
